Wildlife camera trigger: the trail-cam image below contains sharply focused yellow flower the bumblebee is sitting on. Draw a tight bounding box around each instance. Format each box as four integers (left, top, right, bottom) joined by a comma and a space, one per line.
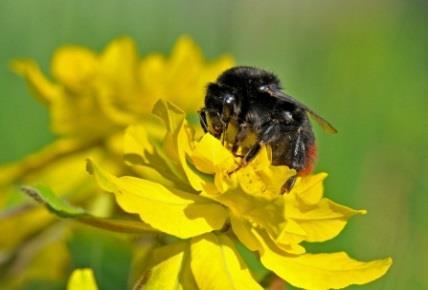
88, 101, 391, 289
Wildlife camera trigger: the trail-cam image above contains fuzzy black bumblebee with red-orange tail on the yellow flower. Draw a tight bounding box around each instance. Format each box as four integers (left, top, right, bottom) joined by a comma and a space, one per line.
199, 66, 337, 192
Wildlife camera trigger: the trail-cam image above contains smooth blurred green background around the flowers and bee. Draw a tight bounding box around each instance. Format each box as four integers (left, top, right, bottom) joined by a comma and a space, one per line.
0, 0, 428, 290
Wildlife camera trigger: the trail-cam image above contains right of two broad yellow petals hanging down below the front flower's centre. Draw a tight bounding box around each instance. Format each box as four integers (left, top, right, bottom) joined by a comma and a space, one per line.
191, 233, 262, 290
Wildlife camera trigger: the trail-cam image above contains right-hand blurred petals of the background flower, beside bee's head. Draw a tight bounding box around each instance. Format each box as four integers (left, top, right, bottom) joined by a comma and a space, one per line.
139, 36, 234, 112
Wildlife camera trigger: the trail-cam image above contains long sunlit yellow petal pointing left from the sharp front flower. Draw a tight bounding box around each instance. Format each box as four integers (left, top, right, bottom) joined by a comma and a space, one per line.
88, 162, 227, 238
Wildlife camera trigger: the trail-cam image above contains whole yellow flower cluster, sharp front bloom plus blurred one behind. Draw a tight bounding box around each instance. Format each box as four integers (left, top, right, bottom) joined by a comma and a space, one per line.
0, 37, 391, 290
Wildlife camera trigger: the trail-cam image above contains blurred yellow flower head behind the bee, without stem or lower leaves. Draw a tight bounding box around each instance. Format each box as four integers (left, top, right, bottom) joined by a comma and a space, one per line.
13, 36, 233, 139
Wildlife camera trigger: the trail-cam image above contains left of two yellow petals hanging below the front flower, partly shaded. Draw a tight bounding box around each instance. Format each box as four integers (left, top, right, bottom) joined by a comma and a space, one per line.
144, 242, 198, 290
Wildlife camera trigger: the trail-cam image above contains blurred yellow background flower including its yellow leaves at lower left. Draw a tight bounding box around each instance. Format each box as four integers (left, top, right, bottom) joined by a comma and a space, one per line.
0, 36, 233, 288
